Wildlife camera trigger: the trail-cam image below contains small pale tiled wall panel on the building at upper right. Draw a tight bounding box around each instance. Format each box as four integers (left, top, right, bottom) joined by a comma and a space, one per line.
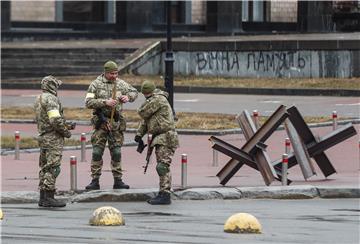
270, 0, 297, 22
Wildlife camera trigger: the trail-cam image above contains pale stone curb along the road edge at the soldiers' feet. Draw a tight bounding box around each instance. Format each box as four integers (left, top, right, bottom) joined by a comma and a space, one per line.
1, 185, 360, 204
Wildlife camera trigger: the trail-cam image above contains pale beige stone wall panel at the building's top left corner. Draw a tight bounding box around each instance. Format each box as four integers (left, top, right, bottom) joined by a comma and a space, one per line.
11, 0, 55, 21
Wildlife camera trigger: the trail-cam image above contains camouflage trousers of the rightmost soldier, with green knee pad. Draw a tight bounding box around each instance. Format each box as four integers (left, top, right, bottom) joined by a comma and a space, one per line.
155, 145, 175, 193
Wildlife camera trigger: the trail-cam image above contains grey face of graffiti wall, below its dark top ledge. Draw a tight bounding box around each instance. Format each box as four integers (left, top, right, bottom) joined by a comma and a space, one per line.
135, 50, 354, 78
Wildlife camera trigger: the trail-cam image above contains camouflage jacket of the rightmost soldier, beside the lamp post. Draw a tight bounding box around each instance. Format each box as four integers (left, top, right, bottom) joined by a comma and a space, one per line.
137, 89, 179, 148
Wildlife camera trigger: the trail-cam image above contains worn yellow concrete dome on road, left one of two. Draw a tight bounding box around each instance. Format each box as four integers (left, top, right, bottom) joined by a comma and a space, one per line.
89, 206, 125, 226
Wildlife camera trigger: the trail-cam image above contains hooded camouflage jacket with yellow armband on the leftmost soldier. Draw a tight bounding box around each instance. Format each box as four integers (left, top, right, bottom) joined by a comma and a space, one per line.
34, 84, 70, 137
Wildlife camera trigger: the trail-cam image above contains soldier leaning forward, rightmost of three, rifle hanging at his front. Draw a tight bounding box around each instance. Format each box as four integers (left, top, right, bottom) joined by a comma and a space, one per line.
135, 81, 179, 205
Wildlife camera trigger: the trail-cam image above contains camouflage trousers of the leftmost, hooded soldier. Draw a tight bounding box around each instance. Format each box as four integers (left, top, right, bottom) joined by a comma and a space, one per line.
39, 149, 62, 191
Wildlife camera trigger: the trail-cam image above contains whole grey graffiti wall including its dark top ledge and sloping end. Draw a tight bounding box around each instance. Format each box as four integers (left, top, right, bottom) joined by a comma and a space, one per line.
124, 40, 360, 78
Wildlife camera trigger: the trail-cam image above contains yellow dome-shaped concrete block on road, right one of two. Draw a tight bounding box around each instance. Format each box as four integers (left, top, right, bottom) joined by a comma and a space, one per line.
224, 213, 261, 234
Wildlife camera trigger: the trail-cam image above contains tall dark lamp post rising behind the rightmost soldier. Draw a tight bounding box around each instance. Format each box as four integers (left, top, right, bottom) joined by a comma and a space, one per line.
165, 1, 175, 114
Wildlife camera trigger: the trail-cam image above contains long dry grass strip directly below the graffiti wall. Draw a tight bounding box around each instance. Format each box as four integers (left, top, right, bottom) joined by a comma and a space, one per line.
5, 74, 360, 90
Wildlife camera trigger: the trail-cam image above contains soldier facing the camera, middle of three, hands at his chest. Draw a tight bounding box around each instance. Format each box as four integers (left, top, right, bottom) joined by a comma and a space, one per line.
85, 61, 138, 190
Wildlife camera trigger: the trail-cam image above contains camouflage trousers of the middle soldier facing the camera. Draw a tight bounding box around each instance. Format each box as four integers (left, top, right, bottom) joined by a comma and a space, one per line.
91, 129, 124, 179
